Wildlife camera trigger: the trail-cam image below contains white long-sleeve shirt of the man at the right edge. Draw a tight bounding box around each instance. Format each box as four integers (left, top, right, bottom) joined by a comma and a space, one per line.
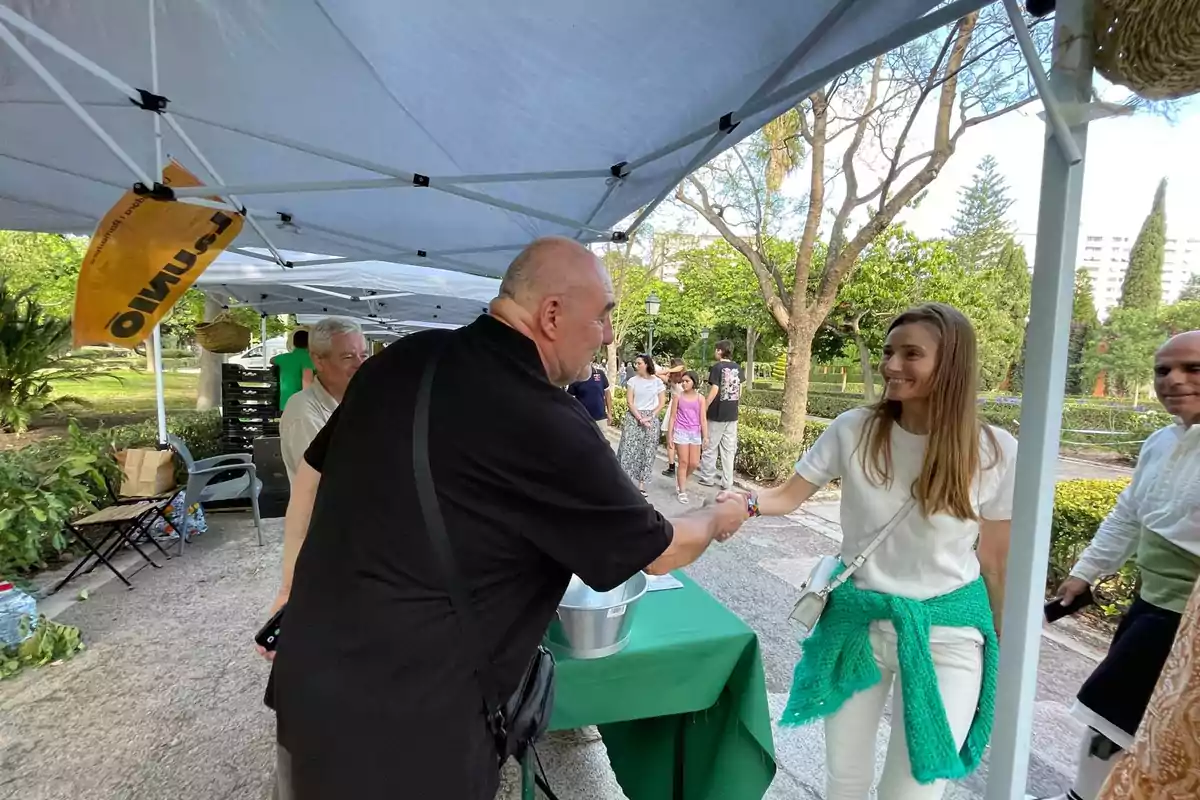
1070, 425, 1200, 583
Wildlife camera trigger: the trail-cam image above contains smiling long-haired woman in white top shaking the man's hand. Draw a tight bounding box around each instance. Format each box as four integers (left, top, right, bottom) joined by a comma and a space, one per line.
719, 303, 1016, 800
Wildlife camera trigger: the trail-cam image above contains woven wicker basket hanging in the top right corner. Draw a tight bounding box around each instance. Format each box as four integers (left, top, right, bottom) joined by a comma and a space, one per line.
1093, 0, 1200, 100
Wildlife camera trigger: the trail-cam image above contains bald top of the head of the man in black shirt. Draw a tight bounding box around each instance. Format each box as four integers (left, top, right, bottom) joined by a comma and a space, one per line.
500, 236, 608, 308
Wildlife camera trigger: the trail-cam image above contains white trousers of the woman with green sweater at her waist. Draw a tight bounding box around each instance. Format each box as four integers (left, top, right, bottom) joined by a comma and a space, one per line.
826, 625, 983, 800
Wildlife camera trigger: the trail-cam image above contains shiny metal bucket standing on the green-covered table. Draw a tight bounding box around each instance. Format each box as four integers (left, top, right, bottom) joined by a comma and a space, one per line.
546, 572, 647, 658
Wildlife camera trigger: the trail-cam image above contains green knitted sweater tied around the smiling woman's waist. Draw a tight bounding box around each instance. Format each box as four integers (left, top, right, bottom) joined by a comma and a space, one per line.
781, 579, 1000, 783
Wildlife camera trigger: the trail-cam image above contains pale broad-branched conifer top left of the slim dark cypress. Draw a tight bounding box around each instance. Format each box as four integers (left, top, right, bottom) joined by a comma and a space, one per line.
946, 156, 1013, 270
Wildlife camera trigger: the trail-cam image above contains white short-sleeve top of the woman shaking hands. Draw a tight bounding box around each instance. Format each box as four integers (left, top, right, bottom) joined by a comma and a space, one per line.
796, 408, 1016, 600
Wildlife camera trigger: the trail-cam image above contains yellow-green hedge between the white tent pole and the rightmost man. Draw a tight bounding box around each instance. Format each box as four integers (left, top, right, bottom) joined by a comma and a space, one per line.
1046, 479, 1138, 614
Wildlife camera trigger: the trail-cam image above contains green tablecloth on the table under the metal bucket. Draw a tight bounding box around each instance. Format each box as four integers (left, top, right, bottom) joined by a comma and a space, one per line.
537, 573, 775, 800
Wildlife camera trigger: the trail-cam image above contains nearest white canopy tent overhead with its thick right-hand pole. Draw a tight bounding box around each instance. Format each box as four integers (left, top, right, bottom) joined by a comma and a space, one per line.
0, 0, 1091, 800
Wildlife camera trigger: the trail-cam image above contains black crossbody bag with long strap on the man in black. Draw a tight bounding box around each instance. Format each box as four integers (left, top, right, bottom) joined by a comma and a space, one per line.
413, 351, 554, 763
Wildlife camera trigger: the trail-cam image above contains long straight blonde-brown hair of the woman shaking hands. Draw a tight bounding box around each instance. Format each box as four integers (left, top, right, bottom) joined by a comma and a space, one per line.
859, 302, 1000, 519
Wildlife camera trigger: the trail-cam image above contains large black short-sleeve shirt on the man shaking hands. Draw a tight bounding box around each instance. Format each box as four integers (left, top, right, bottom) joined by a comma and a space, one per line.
275, 315, 672, 800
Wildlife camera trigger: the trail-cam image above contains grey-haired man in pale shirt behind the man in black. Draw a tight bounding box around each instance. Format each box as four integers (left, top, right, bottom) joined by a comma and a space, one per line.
280, 317, 368, 481
